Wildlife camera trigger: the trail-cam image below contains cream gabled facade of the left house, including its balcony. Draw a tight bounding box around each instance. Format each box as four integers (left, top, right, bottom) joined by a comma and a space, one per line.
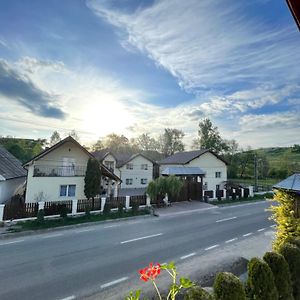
25, 142, 89, 202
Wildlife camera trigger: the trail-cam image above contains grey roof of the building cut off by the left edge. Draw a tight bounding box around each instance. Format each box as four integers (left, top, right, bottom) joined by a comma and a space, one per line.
0, 145, 27, 180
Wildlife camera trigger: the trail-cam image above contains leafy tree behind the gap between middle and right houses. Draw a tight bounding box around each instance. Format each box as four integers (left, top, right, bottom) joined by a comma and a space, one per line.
159, 128, 184, 157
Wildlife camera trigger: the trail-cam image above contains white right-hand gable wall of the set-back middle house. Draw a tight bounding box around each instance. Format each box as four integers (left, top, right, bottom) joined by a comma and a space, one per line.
116, 155, 153, 189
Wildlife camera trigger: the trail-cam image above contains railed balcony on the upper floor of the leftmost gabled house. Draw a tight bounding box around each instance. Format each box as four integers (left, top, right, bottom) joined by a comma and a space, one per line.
33, 165, 86, 177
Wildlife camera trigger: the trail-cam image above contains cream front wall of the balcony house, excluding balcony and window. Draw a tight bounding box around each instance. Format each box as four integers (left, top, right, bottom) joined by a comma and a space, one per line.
25, 142, 89, 202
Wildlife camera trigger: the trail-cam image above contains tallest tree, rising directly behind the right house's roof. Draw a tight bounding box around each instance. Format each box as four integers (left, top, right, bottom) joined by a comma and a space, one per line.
194, 118, 228, 154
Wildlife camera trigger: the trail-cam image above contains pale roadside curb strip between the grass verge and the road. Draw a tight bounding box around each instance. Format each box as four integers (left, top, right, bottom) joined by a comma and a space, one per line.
0, 214, 153, 240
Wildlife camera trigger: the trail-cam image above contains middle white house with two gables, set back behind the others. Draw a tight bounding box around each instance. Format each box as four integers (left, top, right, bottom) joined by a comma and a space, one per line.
93, 149, 154, 192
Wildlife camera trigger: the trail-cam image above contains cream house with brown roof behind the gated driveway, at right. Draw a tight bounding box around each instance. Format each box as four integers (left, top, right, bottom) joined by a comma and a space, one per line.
159, 149, 227, 190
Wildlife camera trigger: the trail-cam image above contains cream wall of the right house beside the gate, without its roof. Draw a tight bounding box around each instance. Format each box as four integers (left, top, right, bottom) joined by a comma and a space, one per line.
159, 152, 227, 190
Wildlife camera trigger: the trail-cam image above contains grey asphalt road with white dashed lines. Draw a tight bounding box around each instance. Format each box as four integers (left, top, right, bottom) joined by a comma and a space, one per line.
0, 202, 273, 300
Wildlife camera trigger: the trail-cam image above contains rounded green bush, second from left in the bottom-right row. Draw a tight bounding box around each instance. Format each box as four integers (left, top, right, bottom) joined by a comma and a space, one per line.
213, 272, 246, 300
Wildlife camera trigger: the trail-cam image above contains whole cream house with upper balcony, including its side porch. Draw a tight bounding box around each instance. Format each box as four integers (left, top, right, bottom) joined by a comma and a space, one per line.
24, 136, 120, 202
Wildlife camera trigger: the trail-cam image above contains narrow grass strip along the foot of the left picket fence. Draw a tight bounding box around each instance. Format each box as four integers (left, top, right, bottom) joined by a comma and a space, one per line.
17, 209, 150, 232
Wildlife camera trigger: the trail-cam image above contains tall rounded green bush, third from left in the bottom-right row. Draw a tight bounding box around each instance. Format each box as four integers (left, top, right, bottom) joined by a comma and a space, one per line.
248, 257, 278, 300
